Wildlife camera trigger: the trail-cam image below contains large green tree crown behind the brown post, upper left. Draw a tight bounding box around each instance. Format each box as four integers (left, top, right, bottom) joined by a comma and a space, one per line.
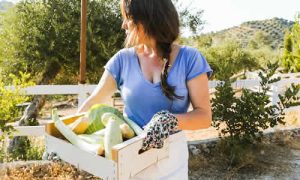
0, 0, 124, 83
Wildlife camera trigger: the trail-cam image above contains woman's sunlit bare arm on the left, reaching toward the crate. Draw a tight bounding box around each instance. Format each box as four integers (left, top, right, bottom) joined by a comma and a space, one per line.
77, 70, 117, 113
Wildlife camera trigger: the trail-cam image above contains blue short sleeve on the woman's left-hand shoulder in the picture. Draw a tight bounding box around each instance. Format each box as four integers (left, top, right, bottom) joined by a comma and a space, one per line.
104, 52, 122, 89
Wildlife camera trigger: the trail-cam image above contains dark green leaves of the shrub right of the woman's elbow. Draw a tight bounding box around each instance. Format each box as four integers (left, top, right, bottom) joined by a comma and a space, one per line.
212, 63, 300, 144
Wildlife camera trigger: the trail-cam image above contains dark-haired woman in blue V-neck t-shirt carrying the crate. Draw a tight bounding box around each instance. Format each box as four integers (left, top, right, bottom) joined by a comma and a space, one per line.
78, 0, 212, 180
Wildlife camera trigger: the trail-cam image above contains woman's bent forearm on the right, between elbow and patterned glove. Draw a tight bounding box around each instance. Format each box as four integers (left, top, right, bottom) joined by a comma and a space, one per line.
175, 109, 212, 130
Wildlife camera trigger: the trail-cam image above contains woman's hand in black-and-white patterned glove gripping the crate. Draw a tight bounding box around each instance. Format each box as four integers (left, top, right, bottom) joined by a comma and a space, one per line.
141, 111, 179, 151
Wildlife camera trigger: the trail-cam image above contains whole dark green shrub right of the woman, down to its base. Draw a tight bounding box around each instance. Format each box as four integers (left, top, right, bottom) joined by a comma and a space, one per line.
212, 63, 300, 168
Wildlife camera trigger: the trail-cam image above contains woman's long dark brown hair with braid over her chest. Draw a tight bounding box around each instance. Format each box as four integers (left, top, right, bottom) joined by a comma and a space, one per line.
121, 0, 183, 100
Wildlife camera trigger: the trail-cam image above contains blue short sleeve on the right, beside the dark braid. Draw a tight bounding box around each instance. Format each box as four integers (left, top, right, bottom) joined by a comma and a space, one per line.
186, 50, 213, 81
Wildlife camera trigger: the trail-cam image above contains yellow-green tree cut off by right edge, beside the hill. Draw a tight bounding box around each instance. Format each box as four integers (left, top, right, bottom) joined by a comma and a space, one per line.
282, 13, 300, 73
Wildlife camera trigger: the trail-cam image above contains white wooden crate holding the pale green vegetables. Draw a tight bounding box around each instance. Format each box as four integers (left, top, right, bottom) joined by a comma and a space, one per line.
46, 116, 184, 180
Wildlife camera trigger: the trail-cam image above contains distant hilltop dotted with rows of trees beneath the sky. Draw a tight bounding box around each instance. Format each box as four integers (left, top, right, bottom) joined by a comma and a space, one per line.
199, 18, 294, 49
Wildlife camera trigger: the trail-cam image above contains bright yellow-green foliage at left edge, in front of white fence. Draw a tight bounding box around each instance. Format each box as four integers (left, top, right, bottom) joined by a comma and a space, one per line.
0, 73, 34, 139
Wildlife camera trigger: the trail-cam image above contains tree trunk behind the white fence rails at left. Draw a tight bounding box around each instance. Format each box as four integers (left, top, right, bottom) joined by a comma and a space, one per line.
8, 61, 61, 160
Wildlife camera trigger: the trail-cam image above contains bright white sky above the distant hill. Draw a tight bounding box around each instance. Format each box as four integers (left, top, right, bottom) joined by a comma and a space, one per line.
4, 0, 300, 33
